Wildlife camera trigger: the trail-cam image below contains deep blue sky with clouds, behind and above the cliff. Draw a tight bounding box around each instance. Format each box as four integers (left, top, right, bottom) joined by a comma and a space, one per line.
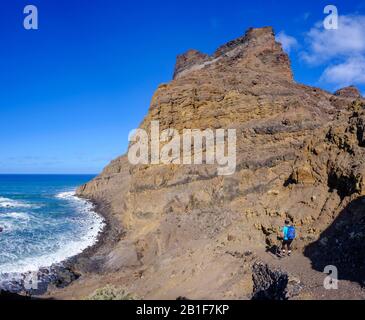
0, 0, 365, 173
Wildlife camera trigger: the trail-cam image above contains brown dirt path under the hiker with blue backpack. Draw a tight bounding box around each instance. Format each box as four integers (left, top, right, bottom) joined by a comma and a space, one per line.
253, 251, 365, 300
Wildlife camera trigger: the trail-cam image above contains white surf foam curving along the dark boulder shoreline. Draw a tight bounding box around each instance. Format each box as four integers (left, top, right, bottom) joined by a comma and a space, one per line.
0, 191, 105, 276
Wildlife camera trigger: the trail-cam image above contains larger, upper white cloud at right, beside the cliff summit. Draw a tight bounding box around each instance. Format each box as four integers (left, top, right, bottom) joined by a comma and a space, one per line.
302, 15, 365, 64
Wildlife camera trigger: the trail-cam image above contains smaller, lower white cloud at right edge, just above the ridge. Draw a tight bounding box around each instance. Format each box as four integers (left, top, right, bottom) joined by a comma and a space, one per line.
320, 56, 365, 88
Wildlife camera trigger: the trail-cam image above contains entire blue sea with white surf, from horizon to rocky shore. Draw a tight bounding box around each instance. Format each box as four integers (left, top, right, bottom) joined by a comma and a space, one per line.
0, 175, 104, 278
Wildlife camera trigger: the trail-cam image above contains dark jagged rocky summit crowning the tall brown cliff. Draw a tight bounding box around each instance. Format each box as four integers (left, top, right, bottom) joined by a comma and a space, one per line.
174, 27, 293, 81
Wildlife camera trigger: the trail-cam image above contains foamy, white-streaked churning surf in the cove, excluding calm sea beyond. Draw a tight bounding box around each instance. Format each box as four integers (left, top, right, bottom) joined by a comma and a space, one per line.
0, 190, 105, 288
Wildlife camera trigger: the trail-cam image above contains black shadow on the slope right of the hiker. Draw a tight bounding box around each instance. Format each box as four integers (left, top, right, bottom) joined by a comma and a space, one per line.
304, 197, 365, 286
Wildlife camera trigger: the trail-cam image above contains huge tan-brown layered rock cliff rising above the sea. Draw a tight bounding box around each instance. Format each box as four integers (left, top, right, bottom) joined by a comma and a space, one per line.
78, 27, 365, 298
